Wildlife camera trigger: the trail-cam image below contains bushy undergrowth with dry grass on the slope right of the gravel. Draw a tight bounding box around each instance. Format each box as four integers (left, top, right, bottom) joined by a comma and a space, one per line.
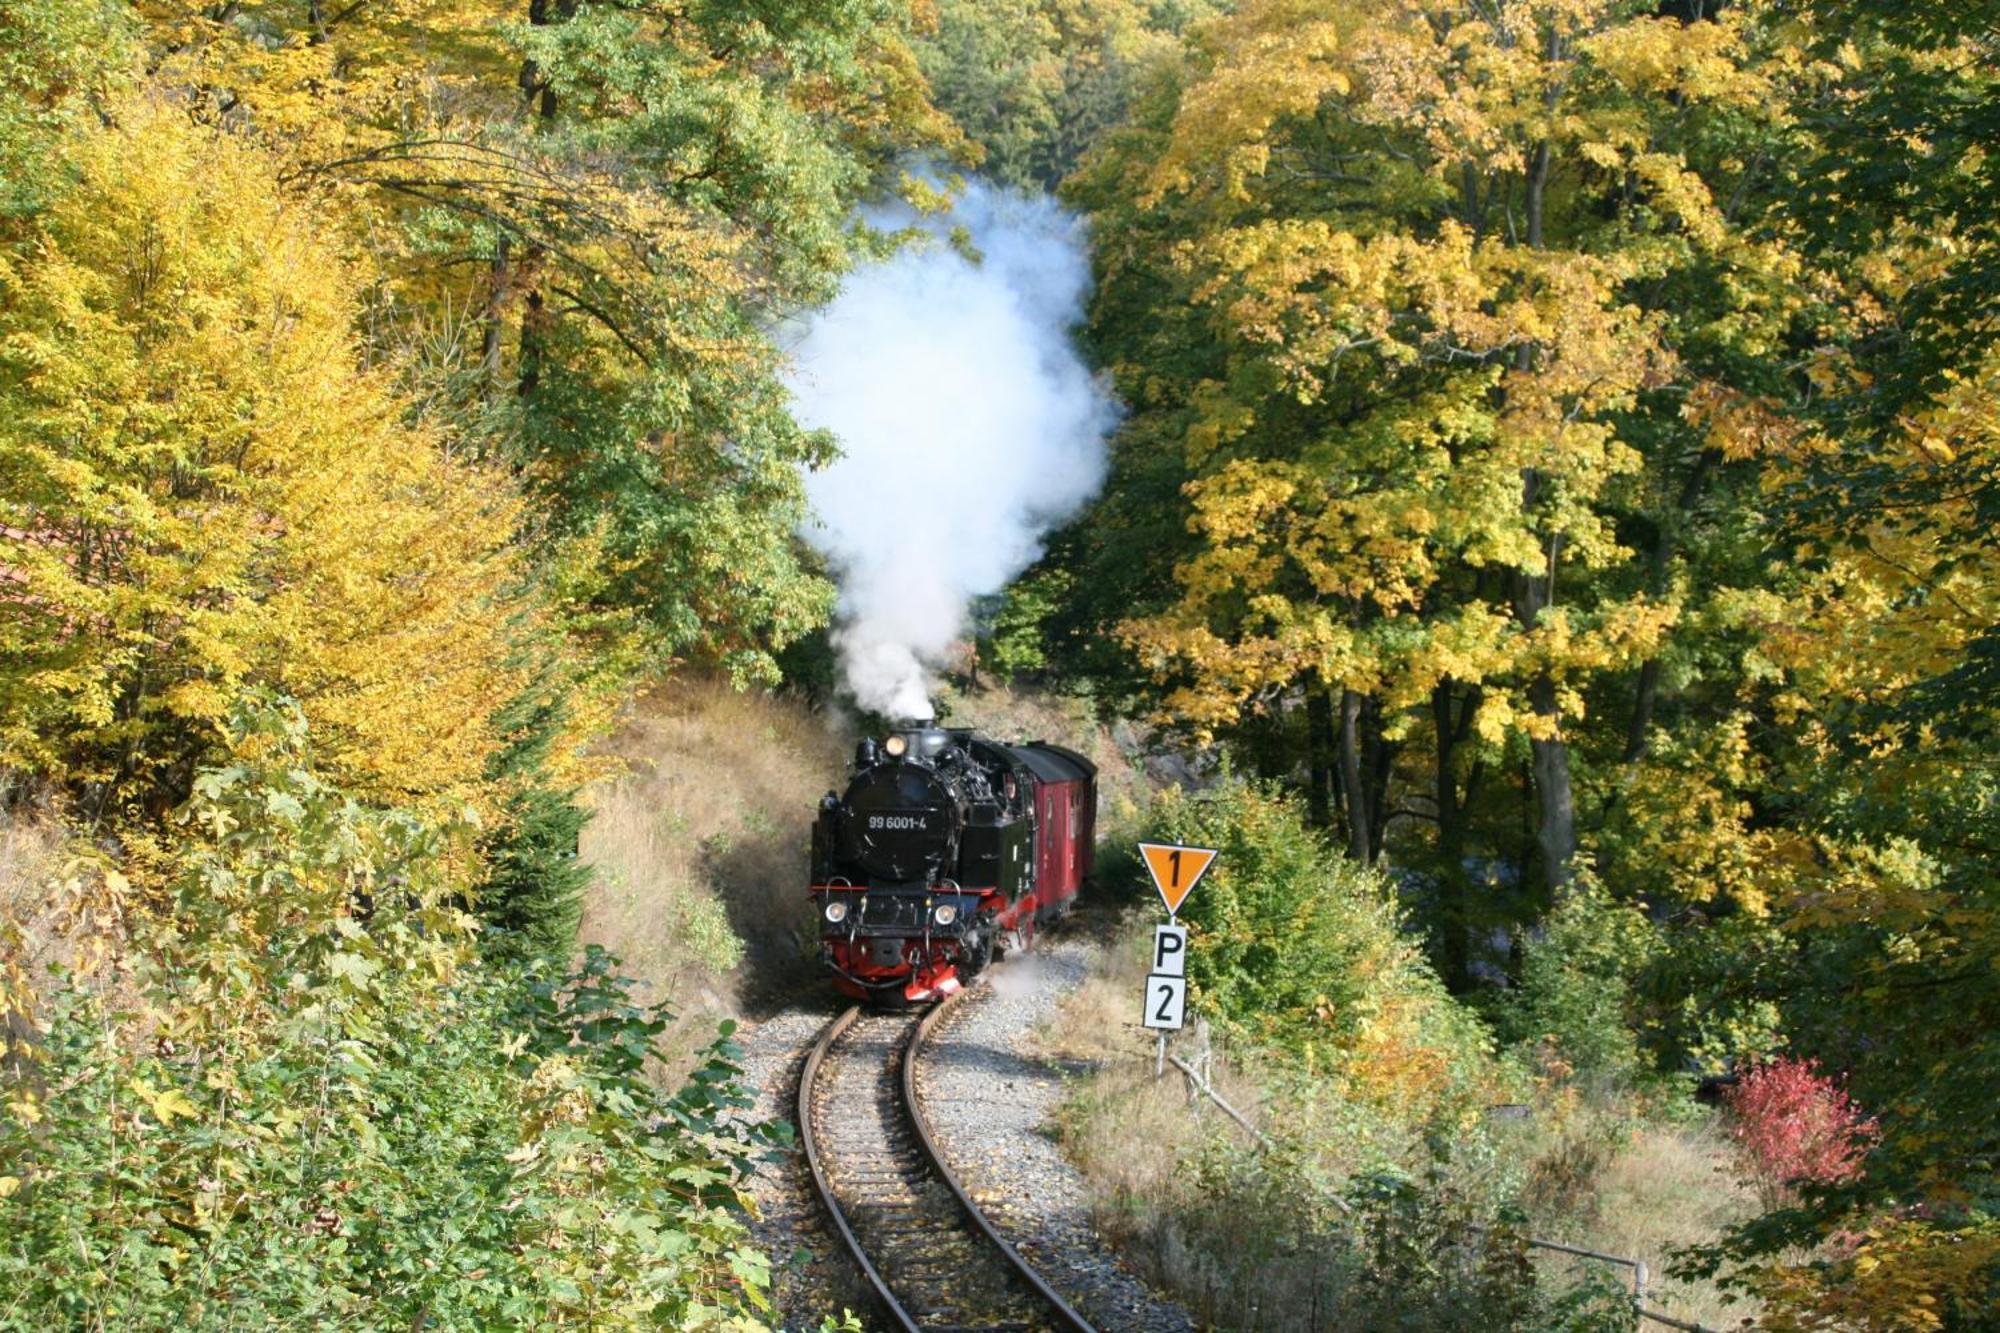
1034, 791, 1760, 1333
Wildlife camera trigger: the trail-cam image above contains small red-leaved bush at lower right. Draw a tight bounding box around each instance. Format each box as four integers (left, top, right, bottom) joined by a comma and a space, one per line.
1724, 1059, 1876, 1203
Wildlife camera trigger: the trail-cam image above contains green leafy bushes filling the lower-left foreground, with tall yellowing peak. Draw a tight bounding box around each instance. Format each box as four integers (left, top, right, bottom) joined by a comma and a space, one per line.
0, 711, 774, 1329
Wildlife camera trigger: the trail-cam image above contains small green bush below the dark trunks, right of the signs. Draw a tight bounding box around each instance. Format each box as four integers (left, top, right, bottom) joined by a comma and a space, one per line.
1496, 881, 1662, 1083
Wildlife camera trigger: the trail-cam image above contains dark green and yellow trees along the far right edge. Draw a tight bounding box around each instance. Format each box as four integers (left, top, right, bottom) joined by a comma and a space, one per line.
1672, 0, 2000, 1304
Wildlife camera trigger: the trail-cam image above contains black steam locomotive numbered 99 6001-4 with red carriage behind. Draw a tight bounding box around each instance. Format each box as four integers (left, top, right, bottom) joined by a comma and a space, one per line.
812, 723, 1098, 1003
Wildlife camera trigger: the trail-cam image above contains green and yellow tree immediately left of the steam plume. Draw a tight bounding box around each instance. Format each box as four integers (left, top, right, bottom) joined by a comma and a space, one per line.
139, 0, 952, 681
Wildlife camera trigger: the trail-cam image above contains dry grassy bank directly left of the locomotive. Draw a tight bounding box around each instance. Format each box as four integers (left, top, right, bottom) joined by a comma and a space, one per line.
580, 681, 848, 1055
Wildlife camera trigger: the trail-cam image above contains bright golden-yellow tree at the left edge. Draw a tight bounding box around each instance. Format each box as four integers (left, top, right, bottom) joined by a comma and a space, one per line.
0, 100, 532, 813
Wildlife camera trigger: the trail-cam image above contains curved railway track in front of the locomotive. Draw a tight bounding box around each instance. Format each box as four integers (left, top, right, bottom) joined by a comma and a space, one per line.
798, 993, 1094, 1333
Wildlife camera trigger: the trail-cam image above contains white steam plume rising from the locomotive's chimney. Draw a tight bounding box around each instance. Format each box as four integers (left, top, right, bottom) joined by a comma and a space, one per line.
790, 184, 1118, 719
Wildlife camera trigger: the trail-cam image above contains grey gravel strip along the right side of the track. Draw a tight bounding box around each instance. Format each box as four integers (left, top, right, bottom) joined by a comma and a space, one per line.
918, 937, 1196, 1333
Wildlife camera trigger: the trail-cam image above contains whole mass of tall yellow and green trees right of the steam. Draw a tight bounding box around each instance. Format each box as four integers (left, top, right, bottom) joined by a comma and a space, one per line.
1050, 0, 2000, 1327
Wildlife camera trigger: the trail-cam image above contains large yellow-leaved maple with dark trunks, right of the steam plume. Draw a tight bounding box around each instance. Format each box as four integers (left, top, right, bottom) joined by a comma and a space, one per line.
1080, 2, 1798, 980
